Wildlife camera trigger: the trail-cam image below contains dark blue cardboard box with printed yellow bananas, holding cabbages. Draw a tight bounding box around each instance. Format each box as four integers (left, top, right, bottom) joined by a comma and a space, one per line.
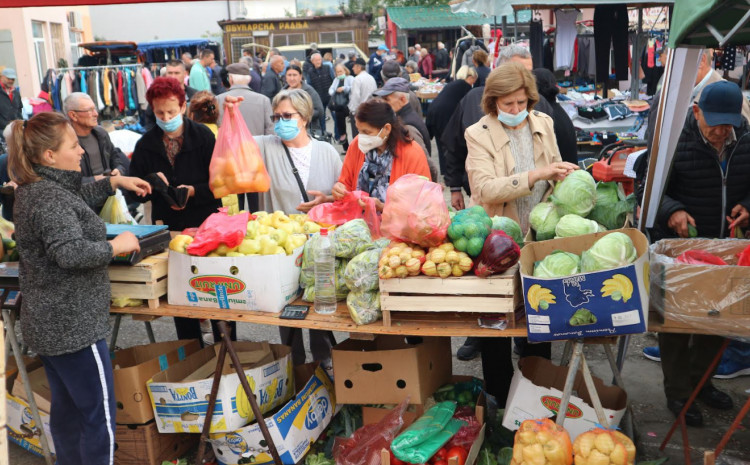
520, 228, 649, 342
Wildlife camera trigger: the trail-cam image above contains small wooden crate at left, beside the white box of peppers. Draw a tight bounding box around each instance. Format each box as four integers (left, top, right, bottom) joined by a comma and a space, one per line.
109, 252, 169, 308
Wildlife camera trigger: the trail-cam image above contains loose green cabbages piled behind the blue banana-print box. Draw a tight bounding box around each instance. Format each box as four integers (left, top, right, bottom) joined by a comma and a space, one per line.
529, 170, 635, 241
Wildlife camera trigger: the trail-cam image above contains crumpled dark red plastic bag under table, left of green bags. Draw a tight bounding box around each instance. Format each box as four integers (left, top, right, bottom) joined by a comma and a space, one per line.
333, 399, 408, 465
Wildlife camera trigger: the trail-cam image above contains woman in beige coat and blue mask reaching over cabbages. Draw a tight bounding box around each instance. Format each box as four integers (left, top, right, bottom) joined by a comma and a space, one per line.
465, 62, 578, 406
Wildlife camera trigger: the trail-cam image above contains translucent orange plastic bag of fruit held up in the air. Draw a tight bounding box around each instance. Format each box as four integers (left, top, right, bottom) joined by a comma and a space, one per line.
208, 101, 271, 199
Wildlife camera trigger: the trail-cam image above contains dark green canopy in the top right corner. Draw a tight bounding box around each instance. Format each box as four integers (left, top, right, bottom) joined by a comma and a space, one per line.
669, 0, 750, 48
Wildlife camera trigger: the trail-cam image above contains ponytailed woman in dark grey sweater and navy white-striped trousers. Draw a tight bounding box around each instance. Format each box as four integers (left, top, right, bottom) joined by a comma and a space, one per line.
8, 113, 151, 465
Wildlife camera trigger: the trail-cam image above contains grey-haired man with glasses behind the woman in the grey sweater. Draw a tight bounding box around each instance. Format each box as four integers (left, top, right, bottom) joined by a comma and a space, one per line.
63, 92, 130, 200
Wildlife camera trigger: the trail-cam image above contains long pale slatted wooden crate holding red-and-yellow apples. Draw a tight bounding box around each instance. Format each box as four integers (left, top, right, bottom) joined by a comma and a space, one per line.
380, 266, 518, 328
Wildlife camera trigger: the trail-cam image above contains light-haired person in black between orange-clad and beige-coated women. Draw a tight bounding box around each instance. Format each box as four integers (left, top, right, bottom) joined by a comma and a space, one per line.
425, 66, 477, 176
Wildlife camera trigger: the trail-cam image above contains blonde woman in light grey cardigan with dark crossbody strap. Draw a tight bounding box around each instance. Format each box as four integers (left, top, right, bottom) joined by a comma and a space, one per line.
255, 89, 342, 365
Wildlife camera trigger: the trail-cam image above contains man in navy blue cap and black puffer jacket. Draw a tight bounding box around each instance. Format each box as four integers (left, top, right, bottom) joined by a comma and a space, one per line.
653, 81, 750, 426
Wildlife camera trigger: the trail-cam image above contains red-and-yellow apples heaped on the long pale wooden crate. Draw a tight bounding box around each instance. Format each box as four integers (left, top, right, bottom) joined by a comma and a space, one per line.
378, 241, 474, 279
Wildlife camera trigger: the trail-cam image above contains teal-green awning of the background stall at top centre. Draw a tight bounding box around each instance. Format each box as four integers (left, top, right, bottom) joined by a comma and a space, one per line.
386, 5, 499, 30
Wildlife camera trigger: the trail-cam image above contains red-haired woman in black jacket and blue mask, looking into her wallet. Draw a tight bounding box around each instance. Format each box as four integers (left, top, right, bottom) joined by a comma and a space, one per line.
130, 77, 236, 341
